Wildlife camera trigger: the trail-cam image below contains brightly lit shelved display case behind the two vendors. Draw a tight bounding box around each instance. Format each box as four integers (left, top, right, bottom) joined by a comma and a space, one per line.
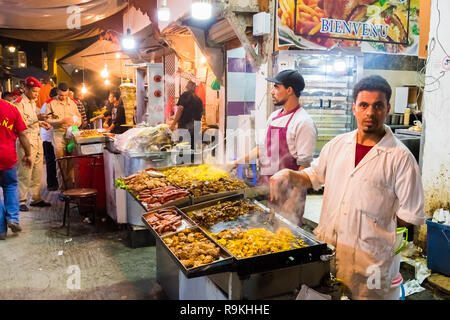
273, 49, 363, 156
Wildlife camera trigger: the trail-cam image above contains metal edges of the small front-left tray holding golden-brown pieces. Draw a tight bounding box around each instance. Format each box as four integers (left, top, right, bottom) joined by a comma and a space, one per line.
156, 226, 235, 278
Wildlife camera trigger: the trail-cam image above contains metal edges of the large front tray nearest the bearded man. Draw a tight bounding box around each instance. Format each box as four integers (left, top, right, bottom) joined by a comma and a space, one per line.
181, 194, 328, 275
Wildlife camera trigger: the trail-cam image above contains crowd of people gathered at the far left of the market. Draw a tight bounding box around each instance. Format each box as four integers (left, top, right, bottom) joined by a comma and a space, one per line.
0, 77, 127, 240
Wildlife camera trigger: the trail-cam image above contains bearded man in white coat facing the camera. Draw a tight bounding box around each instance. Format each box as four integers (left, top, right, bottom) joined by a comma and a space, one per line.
270, 76, 425, 299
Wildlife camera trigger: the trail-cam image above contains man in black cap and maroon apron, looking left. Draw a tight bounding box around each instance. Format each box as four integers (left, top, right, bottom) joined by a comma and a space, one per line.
231, 70, 317, 226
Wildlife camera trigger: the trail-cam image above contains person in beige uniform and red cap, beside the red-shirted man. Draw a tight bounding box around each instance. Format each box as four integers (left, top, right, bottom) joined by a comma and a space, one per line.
14, 77, 51, 211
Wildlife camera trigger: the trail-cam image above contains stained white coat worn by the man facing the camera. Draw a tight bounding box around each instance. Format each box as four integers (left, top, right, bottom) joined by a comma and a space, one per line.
303, 126, 425, 299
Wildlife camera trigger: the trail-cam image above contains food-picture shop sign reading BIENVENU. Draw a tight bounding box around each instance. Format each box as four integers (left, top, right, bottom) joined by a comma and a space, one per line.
276, 0, 419, 55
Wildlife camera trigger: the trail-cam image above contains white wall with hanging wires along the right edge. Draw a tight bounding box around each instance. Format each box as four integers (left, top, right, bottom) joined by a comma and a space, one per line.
422, 0, 450, 215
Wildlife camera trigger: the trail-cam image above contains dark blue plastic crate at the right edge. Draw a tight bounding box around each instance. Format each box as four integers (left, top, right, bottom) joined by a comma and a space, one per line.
427, 219, 450, 276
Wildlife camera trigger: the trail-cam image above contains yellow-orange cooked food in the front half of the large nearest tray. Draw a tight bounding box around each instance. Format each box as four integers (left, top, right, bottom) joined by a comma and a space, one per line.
211, 227, 308, 258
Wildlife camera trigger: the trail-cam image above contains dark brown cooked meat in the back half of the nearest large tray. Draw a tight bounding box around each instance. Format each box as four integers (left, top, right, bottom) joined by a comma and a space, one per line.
188, 200, 261, 228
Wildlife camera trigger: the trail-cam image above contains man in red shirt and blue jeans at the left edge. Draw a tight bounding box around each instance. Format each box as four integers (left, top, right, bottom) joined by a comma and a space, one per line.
0, 85, 32, 240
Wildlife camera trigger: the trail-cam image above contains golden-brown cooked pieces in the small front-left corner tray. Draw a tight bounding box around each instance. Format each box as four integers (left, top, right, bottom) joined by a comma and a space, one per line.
163, 229, 220, 269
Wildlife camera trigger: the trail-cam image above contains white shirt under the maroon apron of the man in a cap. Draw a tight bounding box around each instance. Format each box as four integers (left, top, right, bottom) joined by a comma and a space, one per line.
259, 107, 317, 167
